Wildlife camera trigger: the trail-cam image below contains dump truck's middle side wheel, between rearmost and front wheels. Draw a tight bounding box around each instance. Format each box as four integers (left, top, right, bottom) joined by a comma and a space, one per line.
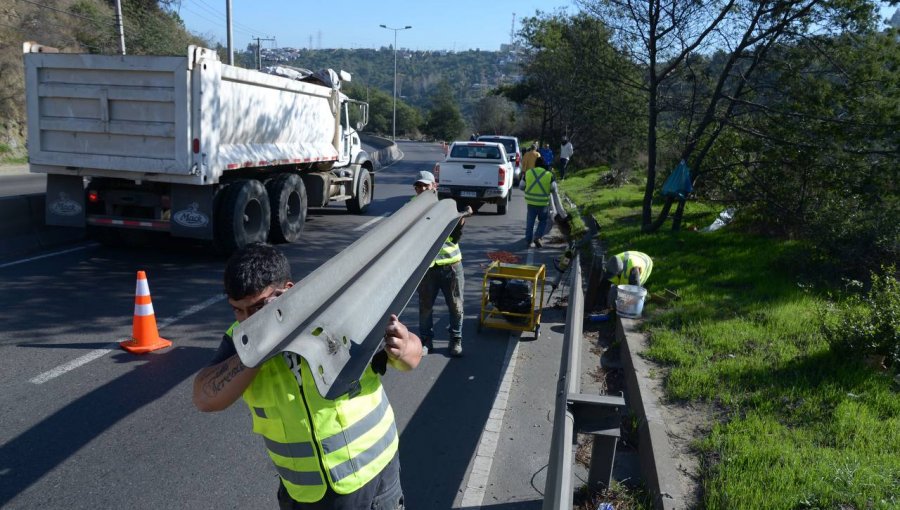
266, 174, 307, 243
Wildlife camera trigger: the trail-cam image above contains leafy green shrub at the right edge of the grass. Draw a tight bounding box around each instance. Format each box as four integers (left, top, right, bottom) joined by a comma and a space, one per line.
822, 266, 900, 370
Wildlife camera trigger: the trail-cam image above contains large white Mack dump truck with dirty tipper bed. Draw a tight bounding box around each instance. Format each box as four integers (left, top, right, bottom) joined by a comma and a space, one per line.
23, 43, 374, 252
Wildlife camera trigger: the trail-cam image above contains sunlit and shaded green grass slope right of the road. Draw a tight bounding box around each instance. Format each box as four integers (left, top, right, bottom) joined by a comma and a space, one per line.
561, 169, 900, 509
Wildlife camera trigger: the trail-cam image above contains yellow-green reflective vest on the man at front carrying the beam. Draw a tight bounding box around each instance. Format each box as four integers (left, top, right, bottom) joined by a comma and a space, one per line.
227, 323, 399, 503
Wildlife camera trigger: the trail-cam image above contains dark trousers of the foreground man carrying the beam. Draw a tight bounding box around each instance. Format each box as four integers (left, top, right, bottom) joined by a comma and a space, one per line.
278, 455, 403, 510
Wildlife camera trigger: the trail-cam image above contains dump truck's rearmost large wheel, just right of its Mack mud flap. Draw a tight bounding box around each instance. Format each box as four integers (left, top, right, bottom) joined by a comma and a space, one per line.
215, 180, 271, 253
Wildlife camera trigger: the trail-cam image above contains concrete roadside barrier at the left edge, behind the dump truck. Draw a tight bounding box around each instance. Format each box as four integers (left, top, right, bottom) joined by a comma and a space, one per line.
0, 194, 85, 259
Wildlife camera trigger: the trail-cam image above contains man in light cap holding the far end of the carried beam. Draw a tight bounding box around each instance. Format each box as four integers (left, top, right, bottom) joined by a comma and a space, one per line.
414, 170, 472, 357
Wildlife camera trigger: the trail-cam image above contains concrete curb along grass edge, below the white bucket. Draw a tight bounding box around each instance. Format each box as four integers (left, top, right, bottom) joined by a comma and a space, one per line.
616, 317, 685, 510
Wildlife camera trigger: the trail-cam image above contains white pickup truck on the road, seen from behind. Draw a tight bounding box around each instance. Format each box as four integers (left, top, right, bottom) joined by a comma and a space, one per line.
434, 142, 515, 214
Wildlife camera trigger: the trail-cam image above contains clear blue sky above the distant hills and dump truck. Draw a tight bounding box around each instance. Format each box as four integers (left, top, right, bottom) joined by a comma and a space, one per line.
173, 0, 577, 51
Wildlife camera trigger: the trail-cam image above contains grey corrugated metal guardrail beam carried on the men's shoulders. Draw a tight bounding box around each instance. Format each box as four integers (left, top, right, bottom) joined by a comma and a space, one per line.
233, 193, 460, 399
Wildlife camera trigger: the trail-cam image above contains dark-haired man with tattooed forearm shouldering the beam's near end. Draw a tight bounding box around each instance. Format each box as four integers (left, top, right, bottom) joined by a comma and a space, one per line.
193, 244, 422, 510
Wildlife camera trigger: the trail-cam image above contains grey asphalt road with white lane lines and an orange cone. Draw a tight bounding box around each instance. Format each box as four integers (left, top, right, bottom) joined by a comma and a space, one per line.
0, 143, 562, 510
